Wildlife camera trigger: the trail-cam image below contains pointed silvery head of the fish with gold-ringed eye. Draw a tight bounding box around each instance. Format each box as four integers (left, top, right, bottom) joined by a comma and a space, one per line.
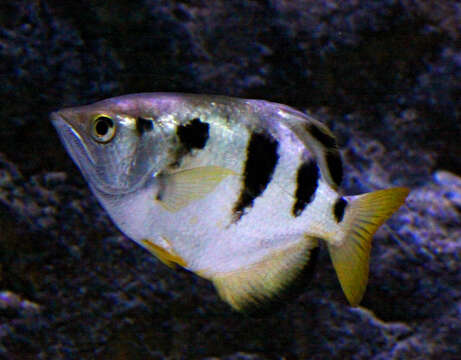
51, 99, 171, 195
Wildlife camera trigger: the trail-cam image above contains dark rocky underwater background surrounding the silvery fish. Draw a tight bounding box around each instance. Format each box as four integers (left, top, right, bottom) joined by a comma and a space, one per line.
0, 0, 461, 360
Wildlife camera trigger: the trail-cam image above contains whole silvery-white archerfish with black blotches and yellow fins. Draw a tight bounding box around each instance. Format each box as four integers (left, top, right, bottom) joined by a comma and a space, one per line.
50, 93, 409, 312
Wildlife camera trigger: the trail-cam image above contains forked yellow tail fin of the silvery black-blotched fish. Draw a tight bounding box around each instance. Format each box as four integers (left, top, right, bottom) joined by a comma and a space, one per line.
328, 188, 409, 306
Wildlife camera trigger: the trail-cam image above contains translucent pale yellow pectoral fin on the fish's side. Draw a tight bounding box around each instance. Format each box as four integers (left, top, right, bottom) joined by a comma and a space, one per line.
157, 166, 237, 212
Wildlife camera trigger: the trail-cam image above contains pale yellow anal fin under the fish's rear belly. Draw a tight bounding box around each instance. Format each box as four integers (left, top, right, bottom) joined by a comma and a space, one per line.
211, 238, 318, 311
